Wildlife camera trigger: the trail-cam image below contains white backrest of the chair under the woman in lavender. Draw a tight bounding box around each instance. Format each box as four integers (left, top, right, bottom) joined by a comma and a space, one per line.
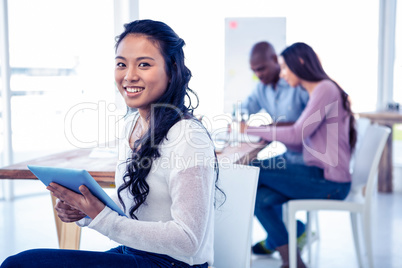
351, 125, 391, 201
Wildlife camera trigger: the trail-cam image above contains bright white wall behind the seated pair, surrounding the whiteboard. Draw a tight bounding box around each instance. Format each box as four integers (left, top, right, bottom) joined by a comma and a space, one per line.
139, 0, 379, 114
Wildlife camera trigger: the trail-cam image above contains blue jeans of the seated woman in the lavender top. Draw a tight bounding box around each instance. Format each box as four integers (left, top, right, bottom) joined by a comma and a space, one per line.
252, 156, 350, 248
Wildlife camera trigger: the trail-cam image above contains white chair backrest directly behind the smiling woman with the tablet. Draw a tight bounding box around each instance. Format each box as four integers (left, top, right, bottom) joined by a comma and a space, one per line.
213, 165, 260, 268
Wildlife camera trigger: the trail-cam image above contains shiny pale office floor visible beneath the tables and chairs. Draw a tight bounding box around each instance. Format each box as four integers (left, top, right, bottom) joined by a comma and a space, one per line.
0, 163, 402, 268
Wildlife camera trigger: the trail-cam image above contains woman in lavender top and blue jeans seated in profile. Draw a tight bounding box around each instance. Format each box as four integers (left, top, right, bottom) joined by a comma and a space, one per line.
247, 43, 356, 267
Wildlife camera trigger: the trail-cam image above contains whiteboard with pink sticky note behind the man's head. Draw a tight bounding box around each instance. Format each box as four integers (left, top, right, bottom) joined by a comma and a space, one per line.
224, 18, 286, 113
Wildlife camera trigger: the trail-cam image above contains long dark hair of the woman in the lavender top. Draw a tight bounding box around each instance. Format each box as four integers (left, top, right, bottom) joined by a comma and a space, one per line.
281, 42, 357, 151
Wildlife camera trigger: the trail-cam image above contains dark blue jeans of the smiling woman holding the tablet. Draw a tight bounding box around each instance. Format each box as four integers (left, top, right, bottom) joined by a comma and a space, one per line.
1, 246, 208, 268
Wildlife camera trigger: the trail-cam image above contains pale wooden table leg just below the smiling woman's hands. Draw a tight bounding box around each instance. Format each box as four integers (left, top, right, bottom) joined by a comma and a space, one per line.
50, 195, 81, 249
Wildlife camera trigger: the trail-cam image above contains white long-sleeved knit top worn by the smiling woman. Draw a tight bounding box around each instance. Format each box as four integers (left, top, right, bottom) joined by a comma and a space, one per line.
76, 120, 215, 264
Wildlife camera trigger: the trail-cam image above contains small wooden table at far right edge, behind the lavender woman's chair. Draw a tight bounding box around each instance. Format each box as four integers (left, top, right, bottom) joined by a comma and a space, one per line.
358, 111, 402, 193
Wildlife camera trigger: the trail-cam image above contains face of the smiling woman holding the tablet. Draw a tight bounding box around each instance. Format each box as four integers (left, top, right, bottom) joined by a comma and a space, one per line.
115, 34, 169, 116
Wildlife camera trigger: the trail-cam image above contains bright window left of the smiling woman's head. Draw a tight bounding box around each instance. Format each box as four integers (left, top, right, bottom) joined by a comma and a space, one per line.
3, 0, 116, 162
